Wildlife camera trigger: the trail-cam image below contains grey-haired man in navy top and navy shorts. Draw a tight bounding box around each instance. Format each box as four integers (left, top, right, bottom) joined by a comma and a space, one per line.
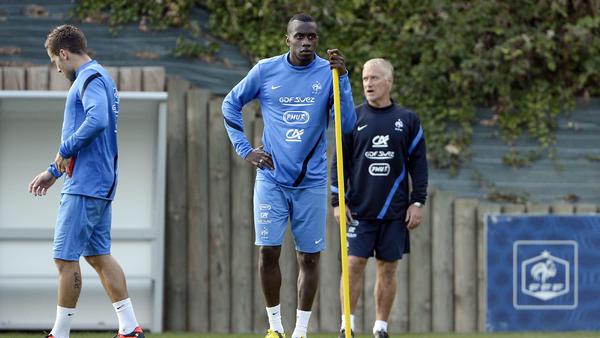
331, 59, 427, 338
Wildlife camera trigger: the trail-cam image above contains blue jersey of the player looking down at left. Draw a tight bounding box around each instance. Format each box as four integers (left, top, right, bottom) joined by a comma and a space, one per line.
49, 60, 119, 200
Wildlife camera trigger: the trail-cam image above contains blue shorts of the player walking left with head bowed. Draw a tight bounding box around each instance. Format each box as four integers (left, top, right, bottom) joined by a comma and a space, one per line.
52, 194, 111, 261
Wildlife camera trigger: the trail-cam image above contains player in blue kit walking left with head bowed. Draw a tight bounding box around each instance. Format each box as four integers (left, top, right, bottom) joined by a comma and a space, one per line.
29, 25, 144, 338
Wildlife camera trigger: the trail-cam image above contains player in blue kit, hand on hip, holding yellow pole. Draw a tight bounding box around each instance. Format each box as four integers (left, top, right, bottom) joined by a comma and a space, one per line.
223, 14, 356, 338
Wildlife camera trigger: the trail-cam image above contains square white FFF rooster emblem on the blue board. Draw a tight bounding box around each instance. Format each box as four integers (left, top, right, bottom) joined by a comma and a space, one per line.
513, 240, 578, 310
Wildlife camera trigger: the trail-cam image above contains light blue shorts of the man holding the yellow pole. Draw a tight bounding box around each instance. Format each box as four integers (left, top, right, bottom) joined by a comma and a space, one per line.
254, 176, 327, 253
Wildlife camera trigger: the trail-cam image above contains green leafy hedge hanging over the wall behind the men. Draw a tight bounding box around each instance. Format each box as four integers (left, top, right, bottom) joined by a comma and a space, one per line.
76, 0, 600, 169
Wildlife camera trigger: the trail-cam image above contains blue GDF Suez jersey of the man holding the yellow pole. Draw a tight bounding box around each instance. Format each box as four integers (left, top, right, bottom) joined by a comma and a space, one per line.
222, 53, 356, 188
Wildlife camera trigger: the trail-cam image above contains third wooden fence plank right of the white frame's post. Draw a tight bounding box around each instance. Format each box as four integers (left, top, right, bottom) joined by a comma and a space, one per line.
208, 98, 232, 333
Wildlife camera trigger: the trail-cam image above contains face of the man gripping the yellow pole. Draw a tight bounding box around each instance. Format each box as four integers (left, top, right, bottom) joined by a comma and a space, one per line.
285, 20, 319, 64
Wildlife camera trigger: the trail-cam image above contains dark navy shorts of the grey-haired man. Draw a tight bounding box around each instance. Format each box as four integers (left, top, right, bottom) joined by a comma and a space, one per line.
346, 218, 410, 262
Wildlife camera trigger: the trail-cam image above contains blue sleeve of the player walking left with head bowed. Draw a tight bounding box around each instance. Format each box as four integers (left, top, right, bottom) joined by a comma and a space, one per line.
59, 79, 108, 158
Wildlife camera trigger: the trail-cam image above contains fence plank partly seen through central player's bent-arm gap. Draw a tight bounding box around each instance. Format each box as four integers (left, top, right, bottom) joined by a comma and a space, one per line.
231, 105, 255, 333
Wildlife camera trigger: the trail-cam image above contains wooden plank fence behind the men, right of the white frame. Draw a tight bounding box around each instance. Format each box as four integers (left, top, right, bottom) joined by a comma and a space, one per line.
164, 78, 598, 333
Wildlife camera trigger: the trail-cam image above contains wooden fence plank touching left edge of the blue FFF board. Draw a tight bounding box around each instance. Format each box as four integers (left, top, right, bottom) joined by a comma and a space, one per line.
477, 204, 501, 332
